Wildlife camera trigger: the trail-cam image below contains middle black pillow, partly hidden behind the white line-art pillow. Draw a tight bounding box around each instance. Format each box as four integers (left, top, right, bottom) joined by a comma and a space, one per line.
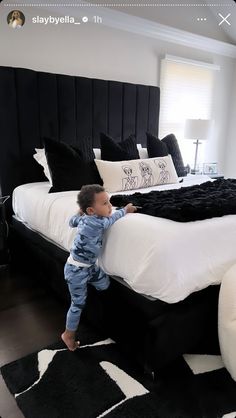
100, 133, 140, 161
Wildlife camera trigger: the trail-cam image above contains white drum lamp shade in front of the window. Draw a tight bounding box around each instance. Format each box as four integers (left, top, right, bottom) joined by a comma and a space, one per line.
184, 119, 211, 140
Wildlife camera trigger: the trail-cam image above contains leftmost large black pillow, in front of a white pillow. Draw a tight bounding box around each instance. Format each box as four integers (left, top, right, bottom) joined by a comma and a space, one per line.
44, 138, 102, 193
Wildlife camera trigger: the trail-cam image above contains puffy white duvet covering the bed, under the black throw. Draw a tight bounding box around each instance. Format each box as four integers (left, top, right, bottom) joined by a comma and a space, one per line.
13, 176, 236, 303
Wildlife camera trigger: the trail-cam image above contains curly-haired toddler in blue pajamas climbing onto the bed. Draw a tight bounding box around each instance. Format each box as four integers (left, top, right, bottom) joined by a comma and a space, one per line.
61, 184, 136, 351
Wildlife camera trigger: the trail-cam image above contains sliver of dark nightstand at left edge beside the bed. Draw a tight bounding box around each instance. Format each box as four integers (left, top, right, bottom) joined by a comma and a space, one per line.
0, 196, 10, 267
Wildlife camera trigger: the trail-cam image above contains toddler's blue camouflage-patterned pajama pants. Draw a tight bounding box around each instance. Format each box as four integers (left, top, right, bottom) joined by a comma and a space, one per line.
64, 263, 110, 331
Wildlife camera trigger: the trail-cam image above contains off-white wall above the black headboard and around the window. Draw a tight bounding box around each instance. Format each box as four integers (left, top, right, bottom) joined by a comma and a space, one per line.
0, 8, 236, 177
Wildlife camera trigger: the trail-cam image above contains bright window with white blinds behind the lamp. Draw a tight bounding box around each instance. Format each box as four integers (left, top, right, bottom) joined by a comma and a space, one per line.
160, 55, 220, 166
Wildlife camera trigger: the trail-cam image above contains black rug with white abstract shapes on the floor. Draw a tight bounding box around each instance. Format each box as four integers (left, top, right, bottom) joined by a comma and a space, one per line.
1, 326, 236, 418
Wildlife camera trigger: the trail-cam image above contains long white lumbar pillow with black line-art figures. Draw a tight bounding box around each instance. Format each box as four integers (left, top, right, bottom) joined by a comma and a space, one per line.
95, 155, 178, 192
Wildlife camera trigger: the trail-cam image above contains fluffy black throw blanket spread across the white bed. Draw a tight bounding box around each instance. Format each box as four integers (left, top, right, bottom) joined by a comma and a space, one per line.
110, 179, 236, 222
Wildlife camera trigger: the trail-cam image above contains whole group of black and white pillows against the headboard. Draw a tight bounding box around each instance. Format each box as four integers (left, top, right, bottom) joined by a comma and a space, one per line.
34, 133, 185, 193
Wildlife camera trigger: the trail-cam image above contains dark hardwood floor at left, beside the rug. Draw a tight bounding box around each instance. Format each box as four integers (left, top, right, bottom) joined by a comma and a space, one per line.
0, 266, 66, 418
